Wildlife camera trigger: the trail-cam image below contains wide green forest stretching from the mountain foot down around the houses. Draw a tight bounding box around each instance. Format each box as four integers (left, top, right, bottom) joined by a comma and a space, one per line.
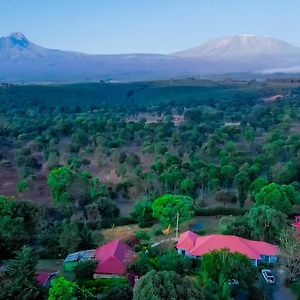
0, 78, 300, 299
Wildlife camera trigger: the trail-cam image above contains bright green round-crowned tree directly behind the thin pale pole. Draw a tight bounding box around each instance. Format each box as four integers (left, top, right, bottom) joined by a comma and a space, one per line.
152, 194, 194, 226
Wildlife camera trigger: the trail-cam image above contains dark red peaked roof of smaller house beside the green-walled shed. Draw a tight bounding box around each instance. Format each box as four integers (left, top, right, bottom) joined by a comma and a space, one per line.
95, 240, 135, 275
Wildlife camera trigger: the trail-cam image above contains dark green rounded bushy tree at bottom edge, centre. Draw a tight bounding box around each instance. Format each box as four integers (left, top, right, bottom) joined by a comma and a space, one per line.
133, 270, 204, 300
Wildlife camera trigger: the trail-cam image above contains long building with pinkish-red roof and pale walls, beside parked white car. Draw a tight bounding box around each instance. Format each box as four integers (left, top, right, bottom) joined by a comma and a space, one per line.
176, 231, 279, 266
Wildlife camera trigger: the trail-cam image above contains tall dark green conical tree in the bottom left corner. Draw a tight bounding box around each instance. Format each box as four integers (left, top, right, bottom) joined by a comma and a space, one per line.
0, 246, 41, 300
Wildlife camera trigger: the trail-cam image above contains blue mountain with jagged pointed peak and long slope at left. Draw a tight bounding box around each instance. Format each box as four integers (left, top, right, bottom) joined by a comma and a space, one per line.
0, 33, 180, 81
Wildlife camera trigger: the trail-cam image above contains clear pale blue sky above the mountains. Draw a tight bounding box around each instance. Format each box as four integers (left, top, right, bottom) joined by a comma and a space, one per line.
0, 0, 300, 54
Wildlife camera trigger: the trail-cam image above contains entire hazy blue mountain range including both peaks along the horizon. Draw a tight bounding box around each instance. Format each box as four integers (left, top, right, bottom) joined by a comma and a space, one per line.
0, 33, 300, 82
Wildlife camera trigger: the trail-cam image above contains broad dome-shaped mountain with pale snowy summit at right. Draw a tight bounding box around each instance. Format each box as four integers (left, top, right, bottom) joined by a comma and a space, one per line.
173, 35, 300, 73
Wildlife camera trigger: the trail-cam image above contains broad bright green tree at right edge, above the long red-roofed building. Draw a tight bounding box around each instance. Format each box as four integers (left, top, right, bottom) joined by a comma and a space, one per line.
255, 183, 300, 213
